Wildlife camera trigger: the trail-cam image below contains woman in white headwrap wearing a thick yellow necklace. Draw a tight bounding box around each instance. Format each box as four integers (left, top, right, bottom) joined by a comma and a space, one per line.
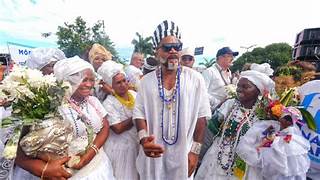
98, 61, 139, 180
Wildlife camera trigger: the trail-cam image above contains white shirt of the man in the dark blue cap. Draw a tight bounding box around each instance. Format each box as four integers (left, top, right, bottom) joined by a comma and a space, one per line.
202, 63, 231, 109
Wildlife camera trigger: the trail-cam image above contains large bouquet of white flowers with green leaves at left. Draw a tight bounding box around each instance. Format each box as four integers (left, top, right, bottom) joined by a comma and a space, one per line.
0, 66, 72, 159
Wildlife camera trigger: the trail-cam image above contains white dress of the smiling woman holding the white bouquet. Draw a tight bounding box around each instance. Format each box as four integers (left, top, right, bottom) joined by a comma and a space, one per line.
14, 96, 114, 180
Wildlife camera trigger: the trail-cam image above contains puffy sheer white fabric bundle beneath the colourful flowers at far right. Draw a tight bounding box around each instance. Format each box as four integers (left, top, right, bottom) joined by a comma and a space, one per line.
237, 121, 310, 180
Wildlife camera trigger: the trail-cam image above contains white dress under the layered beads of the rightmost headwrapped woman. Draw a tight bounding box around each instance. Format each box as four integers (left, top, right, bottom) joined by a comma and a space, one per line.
195, 99, 258, 180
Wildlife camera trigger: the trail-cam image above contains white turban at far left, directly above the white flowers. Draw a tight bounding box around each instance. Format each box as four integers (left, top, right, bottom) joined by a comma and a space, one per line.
27, 48, 66, 70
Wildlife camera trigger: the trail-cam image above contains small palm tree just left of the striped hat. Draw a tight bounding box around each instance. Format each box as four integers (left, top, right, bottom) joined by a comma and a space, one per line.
131, 32, 154, 55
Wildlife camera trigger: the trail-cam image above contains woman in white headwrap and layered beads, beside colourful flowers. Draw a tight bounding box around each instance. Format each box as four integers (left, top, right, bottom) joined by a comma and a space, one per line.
195, 70, 274, 180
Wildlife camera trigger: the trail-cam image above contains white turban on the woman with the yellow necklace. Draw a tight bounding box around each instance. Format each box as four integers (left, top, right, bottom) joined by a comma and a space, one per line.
97, 61, 126, 85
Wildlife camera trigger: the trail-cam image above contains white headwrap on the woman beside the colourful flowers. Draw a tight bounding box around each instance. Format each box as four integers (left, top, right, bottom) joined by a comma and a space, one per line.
240, 70, 275, 95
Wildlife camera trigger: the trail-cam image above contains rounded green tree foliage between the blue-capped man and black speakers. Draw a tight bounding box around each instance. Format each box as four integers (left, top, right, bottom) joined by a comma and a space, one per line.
231, 43, 292, 71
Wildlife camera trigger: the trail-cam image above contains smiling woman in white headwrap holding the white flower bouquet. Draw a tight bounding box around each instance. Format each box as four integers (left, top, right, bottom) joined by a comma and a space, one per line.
16, 56, 114, 180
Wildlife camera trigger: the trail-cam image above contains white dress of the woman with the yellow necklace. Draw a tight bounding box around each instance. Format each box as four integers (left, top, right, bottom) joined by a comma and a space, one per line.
103, 90, 139, 180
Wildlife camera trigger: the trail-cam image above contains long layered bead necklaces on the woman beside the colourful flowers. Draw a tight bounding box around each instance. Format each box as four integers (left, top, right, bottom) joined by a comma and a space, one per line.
217, 100, 256, 175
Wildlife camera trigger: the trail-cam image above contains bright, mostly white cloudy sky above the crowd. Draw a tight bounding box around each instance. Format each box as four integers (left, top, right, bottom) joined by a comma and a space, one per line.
0, 0, 320, 62
